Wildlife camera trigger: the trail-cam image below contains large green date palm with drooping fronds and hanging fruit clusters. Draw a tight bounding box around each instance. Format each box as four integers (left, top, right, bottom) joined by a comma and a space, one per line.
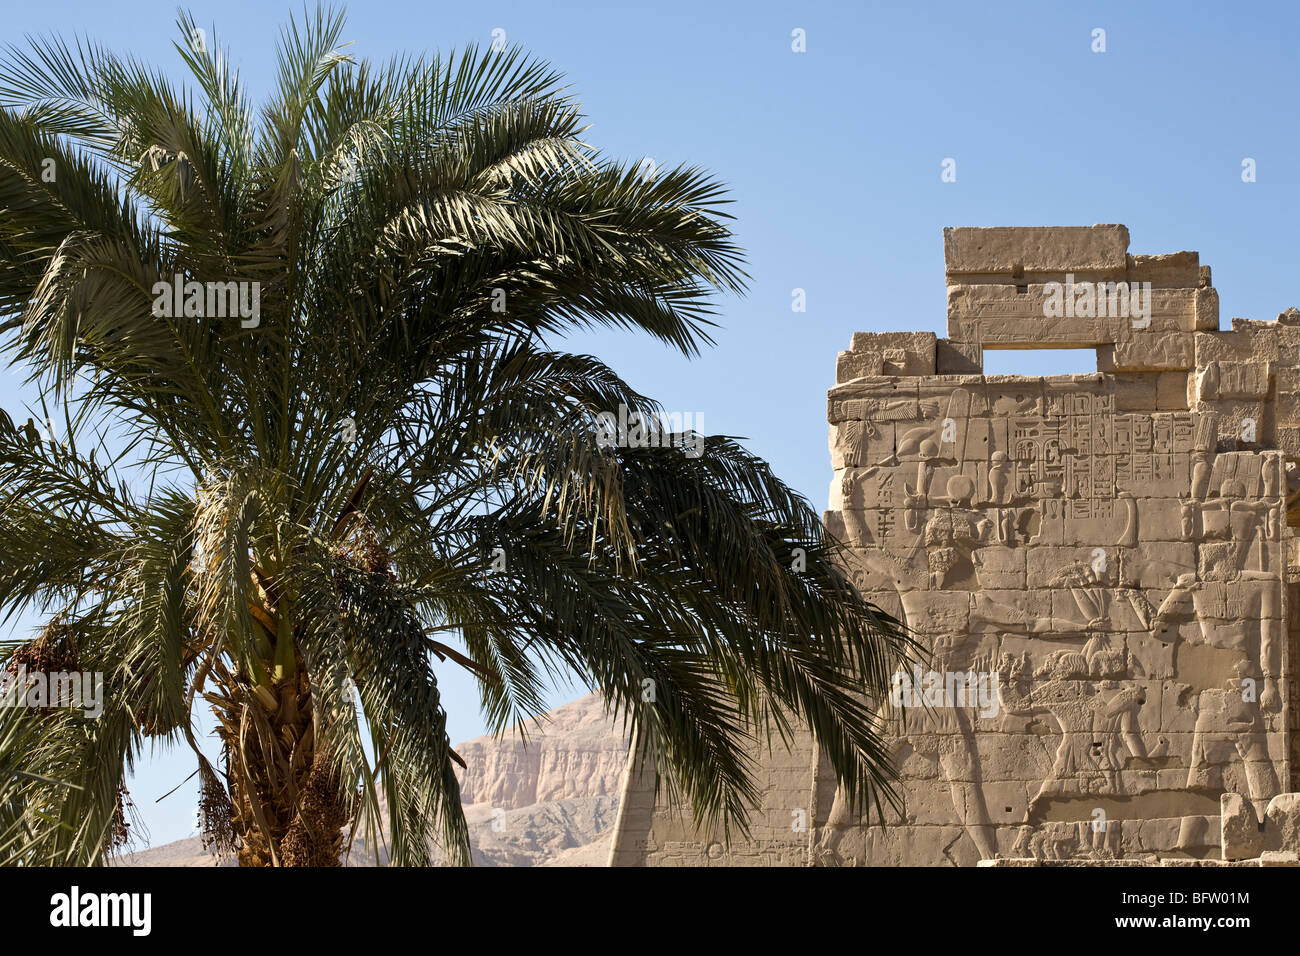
0, 9, 910, 866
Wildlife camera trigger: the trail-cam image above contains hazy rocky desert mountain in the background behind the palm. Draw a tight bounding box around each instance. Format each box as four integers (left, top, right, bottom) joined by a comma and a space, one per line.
116, 693, 628, 866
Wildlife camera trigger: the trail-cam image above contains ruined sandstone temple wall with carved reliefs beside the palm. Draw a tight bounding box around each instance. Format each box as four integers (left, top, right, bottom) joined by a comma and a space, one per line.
611, 225, 1300, 865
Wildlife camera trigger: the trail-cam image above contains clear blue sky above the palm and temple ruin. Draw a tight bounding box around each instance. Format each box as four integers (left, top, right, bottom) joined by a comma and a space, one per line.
0, 0, 1300, 843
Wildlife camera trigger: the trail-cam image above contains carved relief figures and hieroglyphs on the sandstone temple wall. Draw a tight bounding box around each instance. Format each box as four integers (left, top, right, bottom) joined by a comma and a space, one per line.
813, 380, 1286, 864
